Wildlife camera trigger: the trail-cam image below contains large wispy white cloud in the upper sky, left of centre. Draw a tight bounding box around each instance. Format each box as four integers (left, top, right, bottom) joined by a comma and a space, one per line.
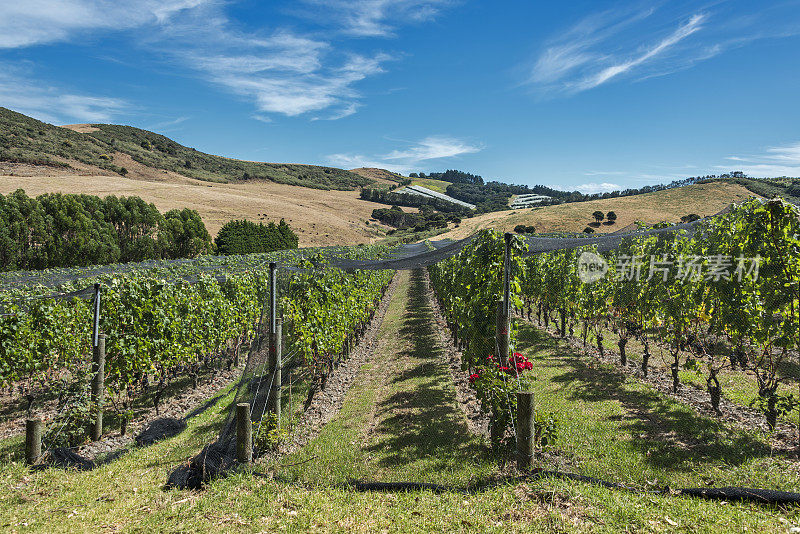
143, 5, 400, 120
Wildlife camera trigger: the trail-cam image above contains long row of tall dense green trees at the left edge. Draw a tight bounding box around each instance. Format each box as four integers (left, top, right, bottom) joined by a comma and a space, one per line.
0, 189, 212, 271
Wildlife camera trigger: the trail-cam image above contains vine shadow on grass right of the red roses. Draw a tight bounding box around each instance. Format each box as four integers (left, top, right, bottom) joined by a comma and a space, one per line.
519, 325, 770, 471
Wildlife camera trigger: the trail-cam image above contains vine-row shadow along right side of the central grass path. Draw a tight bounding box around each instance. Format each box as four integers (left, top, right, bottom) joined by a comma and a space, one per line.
367, 270, 486, 472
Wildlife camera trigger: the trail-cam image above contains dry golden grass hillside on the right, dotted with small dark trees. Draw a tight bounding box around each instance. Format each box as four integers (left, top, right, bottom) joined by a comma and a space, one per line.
441, 182, 754, 239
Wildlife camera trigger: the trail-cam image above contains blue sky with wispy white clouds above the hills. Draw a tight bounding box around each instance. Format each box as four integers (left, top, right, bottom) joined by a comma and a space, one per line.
0, 0, 800, 192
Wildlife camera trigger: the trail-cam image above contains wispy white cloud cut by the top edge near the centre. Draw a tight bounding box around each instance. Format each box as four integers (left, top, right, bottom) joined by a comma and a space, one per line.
296, 0, 454, 37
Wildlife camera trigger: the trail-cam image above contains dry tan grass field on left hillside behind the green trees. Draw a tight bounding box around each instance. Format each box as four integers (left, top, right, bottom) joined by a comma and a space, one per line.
0, 162, 398, 246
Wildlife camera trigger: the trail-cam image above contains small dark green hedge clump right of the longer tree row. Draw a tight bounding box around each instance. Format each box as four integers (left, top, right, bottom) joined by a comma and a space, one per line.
215, 219, 298, 255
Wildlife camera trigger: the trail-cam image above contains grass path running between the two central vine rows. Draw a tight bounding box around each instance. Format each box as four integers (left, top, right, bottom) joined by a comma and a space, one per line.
281, 271, 494, 485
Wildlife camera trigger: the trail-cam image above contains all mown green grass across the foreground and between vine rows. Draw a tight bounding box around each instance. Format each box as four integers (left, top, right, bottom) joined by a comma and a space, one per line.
0, 275, 800, 533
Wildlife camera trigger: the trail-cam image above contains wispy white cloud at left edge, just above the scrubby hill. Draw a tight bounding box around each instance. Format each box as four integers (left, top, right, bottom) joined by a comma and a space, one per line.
0, 63, 131, 124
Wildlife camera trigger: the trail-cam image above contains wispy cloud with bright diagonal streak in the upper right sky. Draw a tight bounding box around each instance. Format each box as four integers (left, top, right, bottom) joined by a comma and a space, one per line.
522, 0, 800, 97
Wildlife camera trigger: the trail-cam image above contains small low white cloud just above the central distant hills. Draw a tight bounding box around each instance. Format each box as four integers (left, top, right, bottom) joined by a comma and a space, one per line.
327, 136, 483, 174
